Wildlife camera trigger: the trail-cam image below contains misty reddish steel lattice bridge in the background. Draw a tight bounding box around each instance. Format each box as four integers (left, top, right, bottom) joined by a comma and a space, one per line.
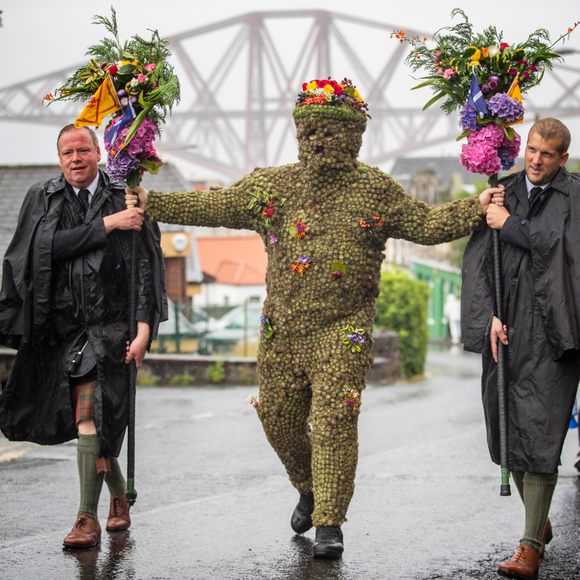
0, 10, 580, 181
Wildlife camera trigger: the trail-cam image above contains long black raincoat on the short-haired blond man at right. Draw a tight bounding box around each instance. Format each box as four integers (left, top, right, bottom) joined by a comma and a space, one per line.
461, 169, 580, 473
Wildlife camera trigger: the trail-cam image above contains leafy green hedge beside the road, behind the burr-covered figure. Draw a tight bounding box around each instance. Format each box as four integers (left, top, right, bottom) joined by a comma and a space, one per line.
375, 270, 429, 377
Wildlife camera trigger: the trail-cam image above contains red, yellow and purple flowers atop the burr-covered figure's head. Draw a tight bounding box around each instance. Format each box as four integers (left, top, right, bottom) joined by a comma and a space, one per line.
296, 78, 368, 116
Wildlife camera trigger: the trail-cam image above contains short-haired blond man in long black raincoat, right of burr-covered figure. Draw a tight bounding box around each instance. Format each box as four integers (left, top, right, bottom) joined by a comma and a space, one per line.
461, 119, 580, 578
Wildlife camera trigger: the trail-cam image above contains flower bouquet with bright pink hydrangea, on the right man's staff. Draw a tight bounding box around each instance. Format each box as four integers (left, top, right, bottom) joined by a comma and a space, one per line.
391, 8, 580, 175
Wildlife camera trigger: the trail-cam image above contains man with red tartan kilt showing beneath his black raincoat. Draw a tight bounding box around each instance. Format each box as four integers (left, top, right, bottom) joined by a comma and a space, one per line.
0, 125, 166, 548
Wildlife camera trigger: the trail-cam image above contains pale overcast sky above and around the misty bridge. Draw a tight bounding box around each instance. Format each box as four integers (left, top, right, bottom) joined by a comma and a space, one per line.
0, 0, 580, 174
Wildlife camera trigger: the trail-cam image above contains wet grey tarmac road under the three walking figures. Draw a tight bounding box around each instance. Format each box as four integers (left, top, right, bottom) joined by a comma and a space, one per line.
0, 346, 580, 580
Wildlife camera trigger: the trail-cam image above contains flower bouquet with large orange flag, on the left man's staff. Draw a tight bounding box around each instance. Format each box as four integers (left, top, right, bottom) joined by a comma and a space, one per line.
44, 8, 179, 187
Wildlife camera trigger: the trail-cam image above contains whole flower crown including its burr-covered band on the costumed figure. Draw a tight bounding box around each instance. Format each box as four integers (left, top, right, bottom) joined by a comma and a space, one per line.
294, 79, 369, 118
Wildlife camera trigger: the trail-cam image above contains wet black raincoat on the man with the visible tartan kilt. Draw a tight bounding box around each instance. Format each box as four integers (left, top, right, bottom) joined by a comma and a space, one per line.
0, 172, 167, 457
